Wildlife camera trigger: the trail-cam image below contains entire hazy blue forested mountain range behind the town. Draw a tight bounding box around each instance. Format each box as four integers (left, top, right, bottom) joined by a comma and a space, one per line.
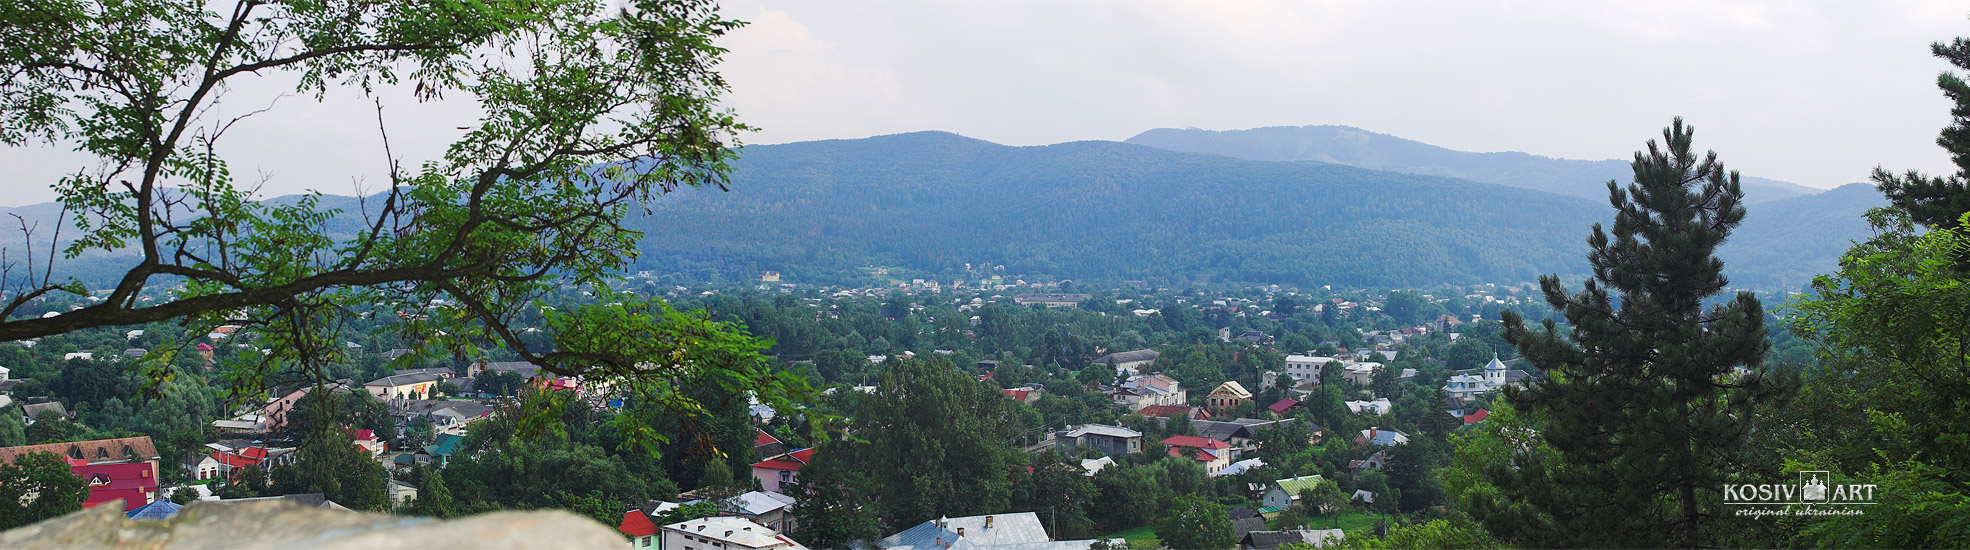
6, 126, 1883, 290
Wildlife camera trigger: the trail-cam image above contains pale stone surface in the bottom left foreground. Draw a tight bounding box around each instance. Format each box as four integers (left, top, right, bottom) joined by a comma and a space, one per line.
0, 501, 626, 550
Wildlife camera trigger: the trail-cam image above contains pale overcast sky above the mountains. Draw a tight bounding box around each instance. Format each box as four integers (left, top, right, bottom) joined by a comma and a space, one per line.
0, 0, 1970, 205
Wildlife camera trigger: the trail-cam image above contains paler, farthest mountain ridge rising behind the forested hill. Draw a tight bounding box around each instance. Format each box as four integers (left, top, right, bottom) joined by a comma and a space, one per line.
1127, 126, 1820, 203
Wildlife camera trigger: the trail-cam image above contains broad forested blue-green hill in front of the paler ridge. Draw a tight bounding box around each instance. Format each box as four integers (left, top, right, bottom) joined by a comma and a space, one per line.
638, 132, 1606, 286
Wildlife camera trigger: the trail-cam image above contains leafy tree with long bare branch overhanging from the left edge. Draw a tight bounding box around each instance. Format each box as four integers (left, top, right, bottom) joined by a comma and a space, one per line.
0, 0, 810, 447
